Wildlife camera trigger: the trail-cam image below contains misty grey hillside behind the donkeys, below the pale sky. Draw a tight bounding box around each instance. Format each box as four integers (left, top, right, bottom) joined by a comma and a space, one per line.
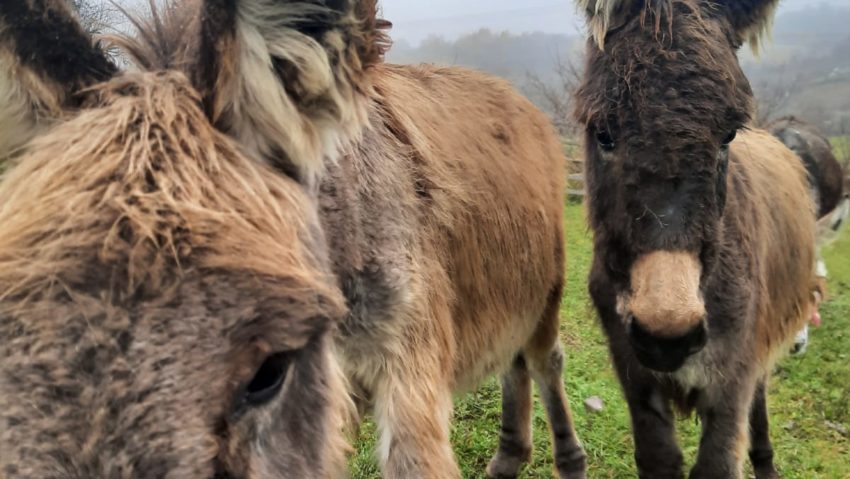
388, 2, 850, 134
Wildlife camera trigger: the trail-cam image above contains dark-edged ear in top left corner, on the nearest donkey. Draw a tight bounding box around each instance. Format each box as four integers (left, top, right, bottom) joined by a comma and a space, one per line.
0, 0, 117, 160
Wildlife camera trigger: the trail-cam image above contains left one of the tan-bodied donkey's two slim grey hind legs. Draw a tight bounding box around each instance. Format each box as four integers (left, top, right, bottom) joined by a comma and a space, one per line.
487, 355, 531, 479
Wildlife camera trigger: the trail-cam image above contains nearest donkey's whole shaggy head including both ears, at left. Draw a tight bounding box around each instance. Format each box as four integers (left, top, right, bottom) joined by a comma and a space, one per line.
0, 0, 374, 479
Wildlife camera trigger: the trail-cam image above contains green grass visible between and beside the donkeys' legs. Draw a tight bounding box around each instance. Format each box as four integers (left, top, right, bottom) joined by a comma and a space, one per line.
350, 205, 850, 479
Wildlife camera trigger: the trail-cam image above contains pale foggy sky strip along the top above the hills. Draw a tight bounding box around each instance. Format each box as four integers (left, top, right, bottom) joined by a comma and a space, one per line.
381, 0, 850, 43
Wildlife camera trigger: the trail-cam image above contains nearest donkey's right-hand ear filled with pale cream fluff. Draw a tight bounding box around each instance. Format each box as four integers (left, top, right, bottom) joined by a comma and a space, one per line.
193, 0, 388, 183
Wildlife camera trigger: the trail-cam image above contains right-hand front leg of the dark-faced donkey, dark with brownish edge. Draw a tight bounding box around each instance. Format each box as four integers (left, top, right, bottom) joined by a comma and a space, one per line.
688, 381, 755, 479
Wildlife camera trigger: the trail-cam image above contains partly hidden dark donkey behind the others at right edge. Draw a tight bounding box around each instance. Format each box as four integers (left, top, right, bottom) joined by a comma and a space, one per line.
765, 116, 850, 354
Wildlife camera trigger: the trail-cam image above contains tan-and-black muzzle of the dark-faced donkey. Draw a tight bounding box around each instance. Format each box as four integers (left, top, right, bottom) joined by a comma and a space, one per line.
617, 251, 708, 373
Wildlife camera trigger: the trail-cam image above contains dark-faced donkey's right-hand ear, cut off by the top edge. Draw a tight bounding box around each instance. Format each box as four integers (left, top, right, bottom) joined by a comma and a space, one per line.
707, 0, 779, 52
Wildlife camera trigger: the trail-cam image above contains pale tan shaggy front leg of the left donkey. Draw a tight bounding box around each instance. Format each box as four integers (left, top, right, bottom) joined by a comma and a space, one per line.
374, 366, 461, 479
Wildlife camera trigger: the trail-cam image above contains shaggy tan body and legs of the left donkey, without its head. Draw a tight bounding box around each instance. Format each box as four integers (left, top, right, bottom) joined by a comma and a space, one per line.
320, 65, 584, 478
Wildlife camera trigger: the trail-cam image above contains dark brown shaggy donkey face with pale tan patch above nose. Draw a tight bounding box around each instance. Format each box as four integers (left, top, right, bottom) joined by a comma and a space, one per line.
577, 0, 774, 371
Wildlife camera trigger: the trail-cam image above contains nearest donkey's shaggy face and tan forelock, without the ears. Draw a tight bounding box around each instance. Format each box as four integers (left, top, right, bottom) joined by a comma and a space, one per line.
0, 0, 362, 479
